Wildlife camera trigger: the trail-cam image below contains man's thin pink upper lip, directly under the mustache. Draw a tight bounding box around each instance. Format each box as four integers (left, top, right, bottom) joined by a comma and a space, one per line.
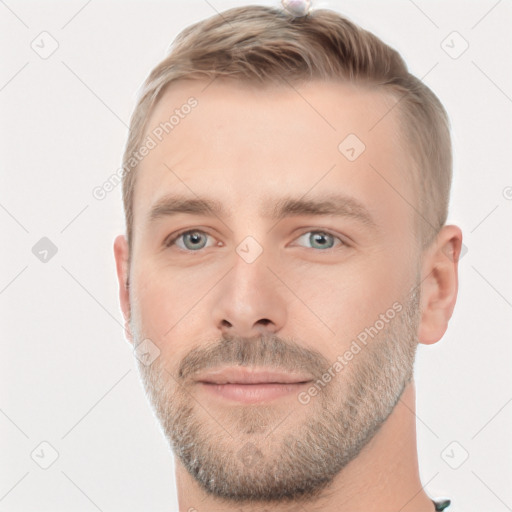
195, 366, 312, 384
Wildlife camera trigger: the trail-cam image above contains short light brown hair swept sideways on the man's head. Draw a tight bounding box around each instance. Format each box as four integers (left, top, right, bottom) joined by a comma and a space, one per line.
123, 6, 452, 249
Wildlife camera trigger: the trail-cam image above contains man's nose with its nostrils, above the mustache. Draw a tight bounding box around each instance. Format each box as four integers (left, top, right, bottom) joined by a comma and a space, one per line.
212, 252, 287, 338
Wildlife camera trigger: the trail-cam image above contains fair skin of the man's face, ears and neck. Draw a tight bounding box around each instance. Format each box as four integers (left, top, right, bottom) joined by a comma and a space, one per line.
114, 79, 462, 512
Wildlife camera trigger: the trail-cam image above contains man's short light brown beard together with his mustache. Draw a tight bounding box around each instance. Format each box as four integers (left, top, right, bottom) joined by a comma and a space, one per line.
132, 288, 420, 504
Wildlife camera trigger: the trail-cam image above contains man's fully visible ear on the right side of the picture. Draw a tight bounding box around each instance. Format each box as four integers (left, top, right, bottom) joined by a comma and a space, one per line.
418, 225, 462, 345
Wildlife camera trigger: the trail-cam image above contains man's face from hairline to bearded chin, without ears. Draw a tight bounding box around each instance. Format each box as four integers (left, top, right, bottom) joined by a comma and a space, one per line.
124, 79, 420, 501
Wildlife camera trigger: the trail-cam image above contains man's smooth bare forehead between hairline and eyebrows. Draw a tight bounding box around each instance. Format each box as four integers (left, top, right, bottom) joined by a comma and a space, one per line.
134, 78, 414, 234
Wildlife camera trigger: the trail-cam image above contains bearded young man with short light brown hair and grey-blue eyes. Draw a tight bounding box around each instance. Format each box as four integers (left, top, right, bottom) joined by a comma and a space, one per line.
114, 6, 462, 512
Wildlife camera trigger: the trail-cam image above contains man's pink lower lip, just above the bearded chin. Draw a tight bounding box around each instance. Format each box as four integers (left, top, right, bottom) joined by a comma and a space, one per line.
200, 382, 308, 404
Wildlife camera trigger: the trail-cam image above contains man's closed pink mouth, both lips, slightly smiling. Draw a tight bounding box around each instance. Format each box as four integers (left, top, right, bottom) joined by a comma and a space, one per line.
196, 366, 313, 403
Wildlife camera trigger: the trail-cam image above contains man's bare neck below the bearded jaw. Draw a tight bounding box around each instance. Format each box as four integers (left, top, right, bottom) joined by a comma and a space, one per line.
176, 381, 434, 512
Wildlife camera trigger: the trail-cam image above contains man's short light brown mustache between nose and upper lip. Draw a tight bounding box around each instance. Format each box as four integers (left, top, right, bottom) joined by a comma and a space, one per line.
177, 335, 329, 381
